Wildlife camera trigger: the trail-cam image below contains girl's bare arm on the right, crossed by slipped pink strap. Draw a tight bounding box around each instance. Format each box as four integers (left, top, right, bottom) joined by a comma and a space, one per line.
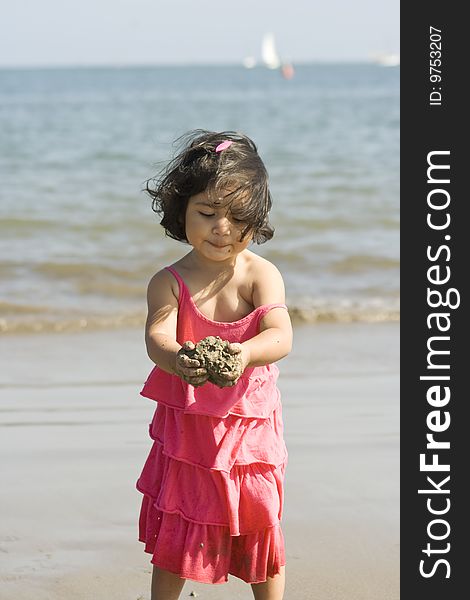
241, 260, 292, 369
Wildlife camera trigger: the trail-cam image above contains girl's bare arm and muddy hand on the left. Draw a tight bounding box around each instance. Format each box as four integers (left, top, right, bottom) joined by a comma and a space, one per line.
145, 270, 208, 385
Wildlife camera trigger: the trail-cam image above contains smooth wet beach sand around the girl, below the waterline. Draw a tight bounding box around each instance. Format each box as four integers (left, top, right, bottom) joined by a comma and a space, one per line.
0, 324, 399, 600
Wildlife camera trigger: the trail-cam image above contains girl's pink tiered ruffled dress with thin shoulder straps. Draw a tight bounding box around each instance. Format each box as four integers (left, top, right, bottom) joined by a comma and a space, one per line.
137, 267, 287, 583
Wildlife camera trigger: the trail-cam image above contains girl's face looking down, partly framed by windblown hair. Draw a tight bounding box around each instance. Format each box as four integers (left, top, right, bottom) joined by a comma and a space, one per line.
185, 190, 252, 262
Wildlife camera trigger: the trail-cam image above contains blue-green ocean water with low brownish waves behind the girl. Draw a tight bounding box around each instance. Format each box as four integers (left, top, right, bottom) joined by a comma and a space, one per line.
0, 64, 399, 332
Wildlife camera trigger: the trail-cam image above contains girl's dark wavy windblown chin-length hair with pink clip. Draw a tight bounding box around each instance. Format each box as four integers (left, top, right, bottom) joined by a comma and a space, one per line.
145, 129, 274, 244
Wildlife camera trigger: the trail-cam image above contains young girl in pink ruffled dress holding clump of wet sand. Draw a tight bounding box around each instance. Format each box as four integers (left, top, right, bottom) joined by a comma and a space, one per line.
137, 131, 292, 600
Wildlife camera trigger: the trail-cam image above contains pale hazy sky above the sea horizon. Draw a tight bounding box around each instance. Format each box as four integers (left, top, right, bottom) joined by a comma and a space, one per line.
0, 0, 400, 67
